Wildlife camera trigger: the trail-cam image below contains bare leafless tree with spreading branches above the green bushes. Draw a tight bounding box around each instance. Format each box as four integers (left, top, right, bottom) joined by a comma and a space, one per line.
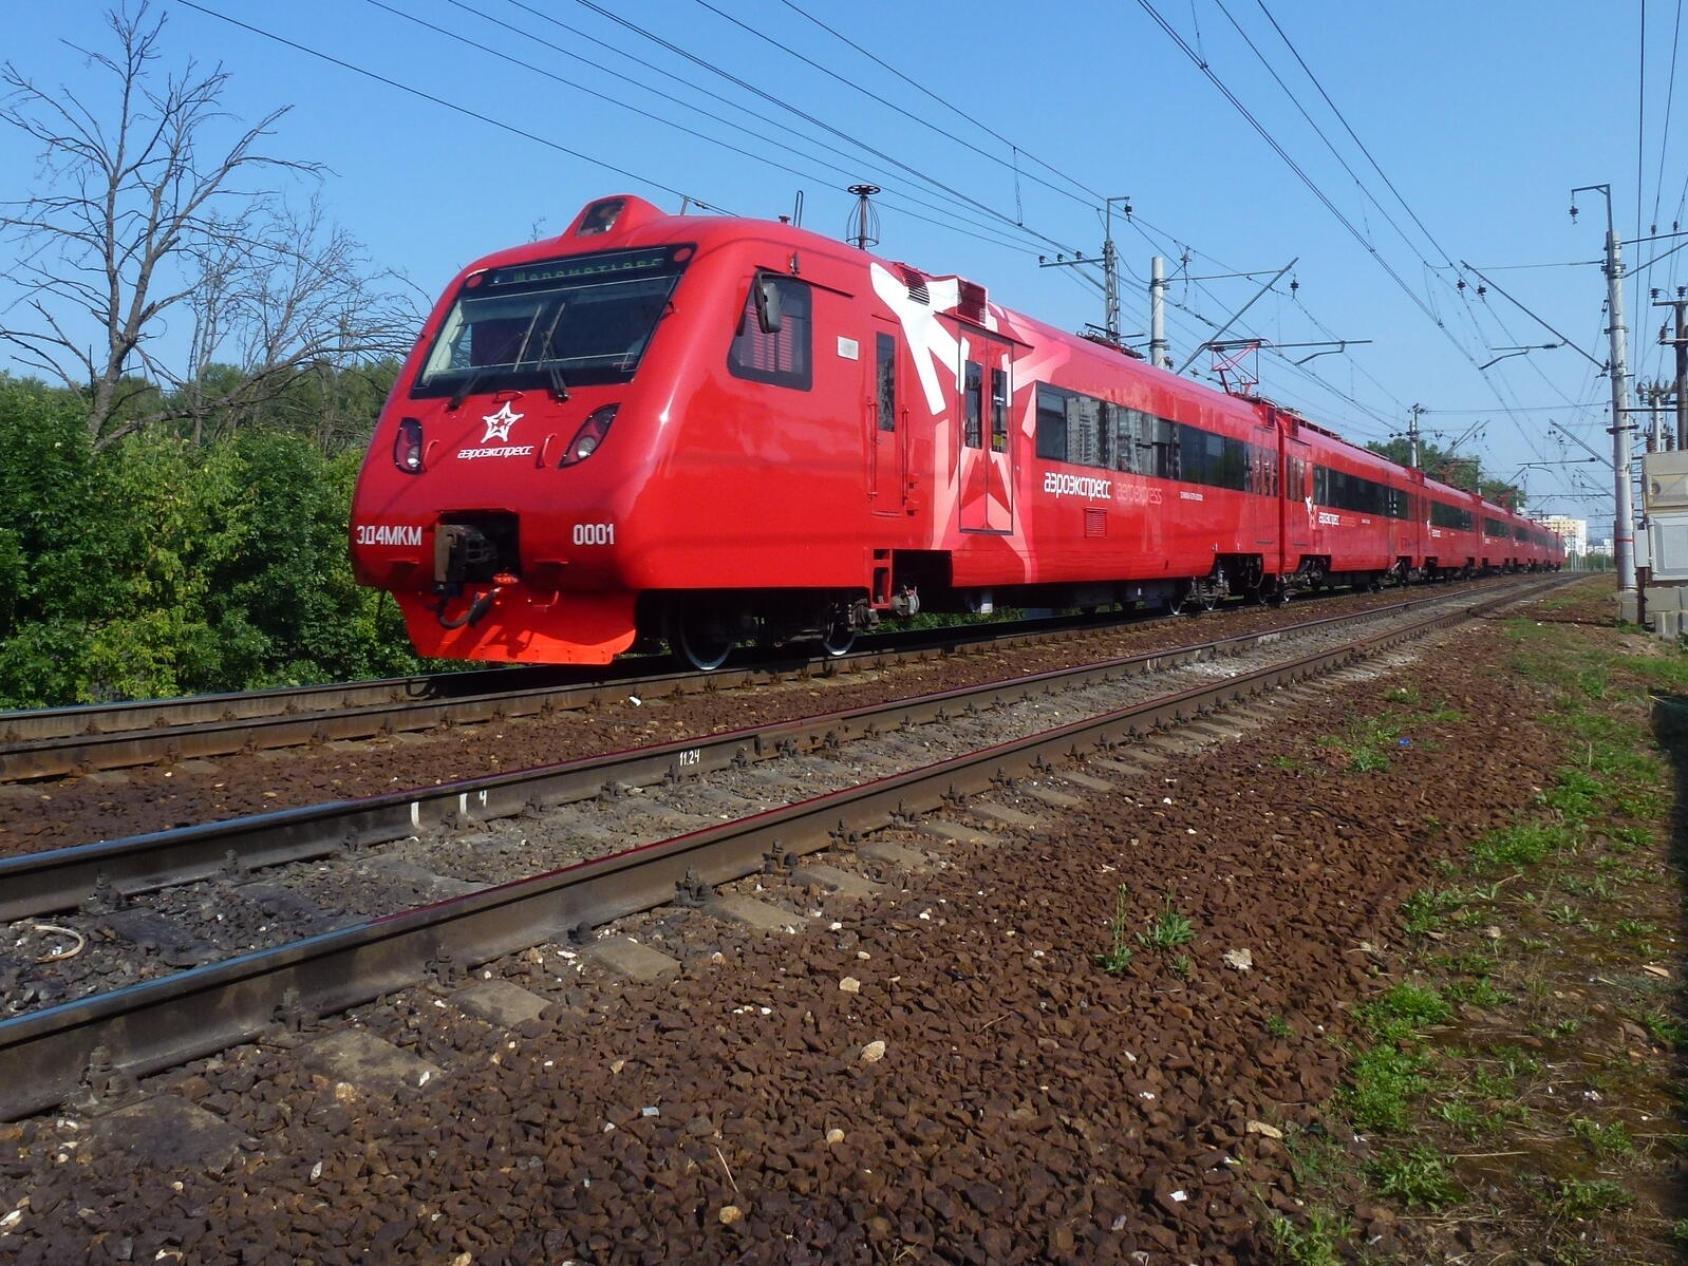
0, 3, 417, 446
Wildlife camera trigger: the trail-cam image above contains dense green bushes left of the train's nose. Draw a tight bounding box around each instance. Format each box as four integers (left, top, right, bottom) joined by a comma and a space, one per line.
0, 375, 417, 707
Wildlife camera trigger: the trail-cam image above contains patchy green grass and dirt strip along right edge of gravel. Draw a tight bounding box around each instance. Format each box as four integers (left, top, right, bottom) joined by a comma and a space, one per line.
1256, 582, 1688, 1266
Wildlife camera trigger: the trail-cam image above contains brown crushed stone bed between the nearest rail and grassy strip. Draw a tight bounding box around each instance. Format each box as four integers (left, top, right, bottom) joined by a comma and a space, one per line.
0, 594, 1579, 1266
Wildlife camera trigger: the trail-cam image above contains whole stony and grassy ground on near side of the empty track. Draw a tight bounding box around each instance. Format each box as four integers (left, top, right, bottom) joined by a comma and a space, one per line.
0, 582, 1667, 1266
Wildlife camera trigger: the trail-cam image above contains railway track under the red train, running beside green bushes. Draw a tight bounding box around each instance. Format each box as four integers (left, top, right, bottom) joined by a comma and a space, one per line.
0, 584, 1505, 783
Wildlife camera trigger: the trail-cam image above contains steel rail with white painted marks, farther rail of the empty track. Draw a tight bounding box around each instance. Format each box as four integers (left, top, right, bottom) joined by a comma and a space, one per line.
0, 584, 1532, 922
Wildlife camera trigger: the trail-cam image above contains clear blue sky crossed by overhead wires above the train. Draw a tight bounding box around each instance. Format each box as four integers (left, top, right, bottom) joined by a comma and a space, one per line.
0, 0, 1667, 537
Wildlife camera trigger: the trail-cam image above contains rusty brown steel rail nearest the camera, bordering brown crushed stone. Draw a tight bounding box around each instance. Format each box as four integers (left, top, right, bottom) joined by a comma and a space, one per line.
0, 586, 1548, 1119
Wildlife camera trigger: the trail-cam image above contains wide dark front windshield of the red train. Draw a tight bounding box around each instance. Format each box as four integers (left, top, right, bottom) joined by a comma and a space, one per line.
410, 246, 692, 395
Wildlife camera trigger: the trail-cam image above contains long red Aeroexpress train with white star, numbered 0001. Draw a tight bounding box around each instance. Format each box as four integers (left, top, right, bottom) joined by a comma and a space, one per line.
351, 196, 1563, 667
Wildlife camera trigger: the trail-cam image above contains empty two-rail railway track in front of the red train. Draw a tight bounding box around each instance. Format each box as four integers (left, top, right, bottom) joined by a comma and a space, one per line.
0, 582, 1553, 1117
